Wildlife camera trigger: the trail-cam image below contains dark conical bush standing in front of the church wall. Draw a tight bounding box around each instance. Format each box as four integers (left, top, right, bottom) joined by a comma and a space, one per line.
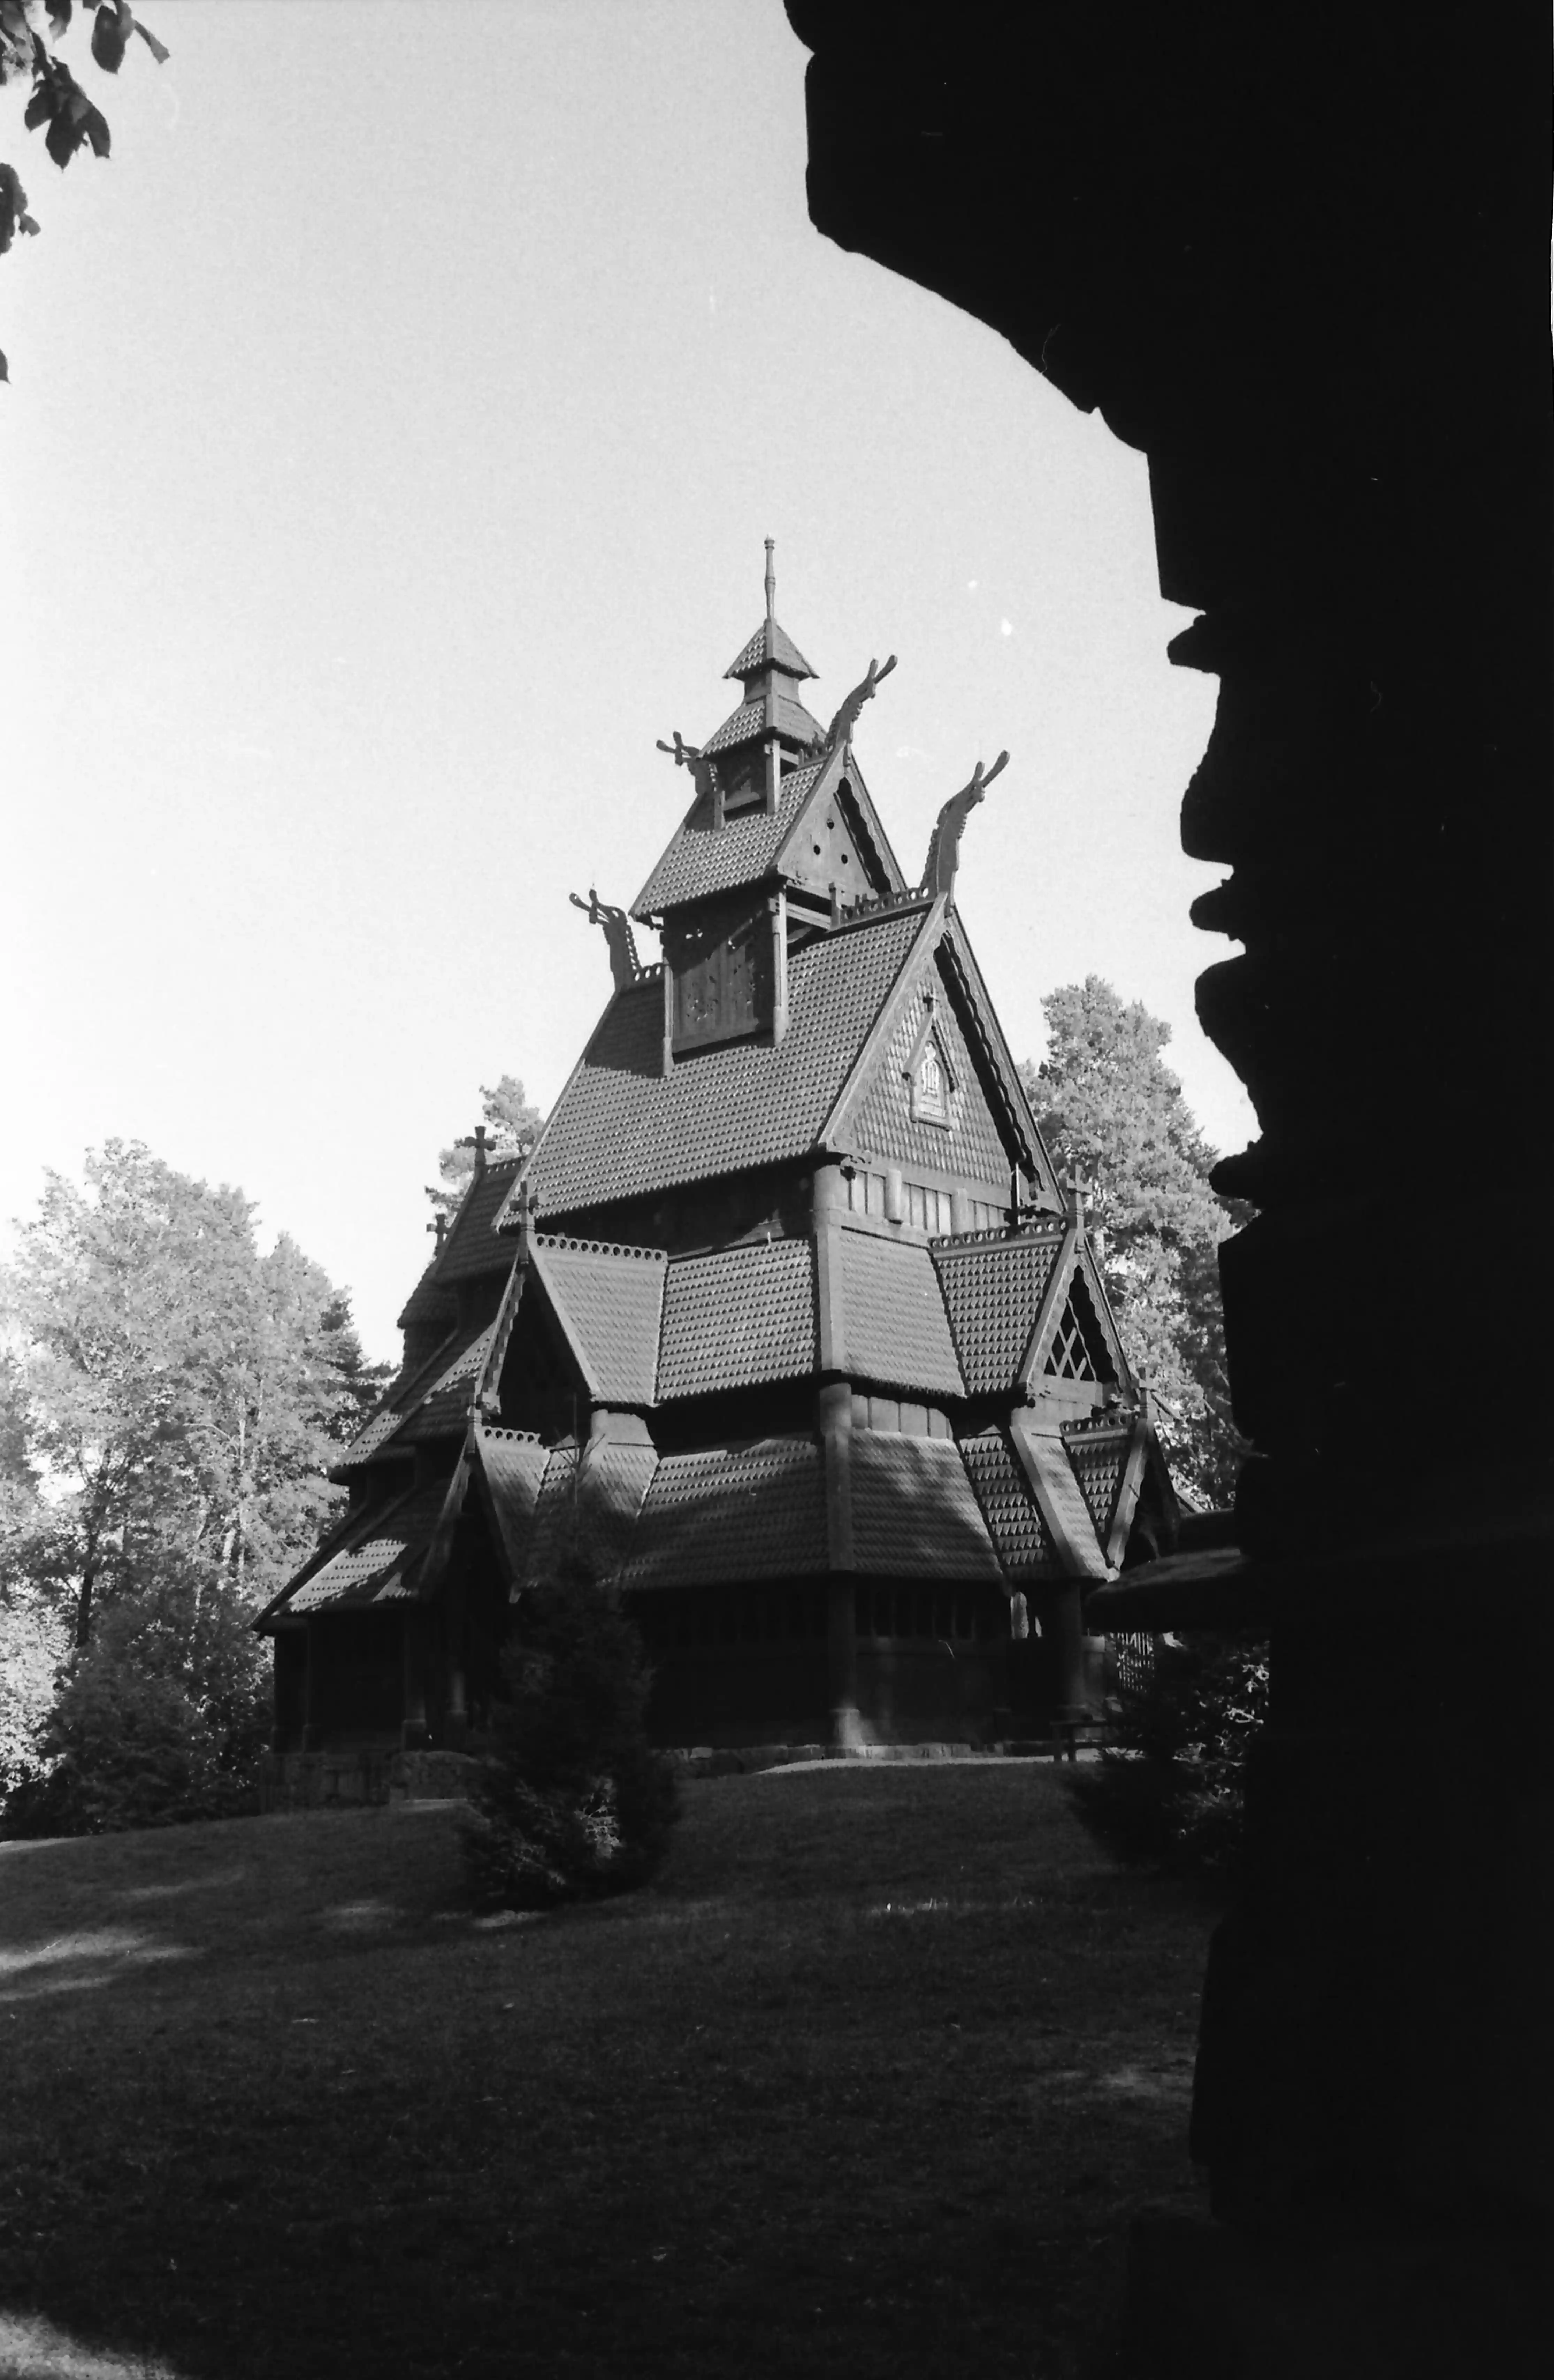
464, 1554, 678, 1909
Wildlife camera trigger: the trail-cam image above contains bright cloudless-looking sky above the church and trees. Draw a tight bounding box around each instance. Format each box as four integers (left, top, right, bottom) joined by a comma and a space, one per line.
0, 0, 1254, 1354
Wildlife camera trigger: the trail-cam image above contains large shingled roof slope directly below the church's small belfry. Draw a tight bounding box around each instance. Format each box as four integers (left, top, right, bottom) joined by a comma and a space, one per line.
528, 907, 928, 1216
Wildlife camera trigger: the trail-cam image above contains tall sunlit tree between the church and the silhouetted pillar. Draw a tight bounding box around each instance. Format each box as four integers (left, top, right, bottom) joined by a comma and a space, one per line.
1021, 976, 1245, 1504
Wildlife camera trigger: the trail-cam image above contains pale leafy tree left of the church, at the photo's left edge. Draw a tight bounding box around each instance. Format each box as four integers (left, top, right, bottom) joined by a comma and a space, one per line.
0, 1140, 369, 1825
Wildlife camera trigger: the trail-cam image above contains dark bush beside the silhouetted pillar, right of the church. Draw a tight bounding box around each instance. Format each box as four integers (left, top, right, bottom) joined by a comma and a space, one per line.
1069, 1630, 1269, 1880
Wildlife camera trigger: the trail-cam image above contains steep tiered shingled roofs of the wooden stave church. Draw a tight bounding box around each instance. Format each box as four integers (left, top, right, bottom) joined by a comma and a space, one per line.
267, 562, 1176, 1621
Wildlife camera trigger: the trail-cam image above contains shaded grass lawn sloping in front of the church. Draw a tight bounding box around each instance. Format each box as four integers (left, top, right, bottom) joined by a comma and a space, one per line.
0, 1764, 1211, 2380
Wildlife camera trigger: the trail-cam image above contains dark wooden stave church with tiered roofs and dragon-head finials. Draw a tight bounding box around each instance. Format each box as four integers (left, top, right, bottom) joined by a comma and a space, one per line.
255, 559, 1178, 1797
